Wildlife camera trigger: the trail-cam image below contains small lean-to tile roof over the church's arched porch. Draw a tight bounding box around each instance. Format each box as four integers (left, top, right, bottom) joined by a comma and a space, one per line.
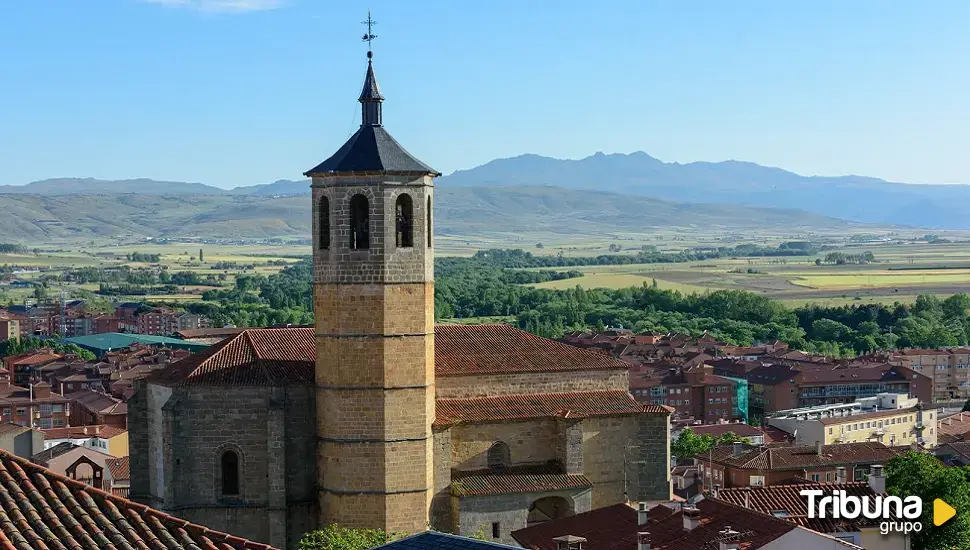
451, 464, 593, 497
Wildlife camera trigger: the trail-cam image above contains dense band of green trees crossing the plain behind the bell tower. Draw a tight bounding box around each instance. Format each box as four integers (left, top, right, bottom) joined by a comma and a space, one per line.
195, 251, 970, 356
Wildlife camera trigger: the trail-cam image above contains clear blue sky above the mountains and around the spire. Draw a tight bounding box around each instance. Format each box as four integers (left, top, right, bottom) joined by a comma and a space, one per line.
0, 0, 970, 187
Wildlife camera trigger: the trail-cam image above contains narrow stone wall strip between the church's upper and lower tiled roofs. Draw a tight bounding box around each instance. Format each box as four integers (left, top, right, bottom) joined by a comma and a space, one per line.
435, 369, 630, 399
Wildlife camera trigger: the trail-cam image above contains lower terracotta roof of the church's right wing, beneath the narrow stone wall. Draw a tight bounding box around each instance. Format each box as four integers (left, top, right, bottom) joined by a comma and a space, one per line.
435, 390, 670, 426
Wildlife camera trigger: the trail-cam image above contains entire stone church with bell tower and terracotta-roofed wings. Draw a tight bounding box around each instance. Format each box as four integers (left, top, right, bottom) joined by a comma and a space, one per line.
128, 47, 671, 547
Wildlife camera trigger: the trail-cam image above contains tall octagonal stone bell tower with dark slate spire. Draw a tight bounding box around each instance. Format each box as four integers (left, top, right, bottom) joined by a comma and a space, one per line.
305, 17, 440, 533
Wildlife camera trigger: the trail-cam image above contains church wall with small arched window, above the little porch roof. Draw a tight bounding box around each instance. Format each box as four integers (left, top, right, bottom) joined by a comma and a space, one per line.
451, 420, 559, 470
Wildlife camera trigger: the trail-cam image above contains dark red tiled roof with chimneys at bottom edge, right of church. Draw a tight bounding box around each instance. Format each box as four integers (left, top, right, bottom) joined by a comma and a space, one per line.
512, 499, 804, 550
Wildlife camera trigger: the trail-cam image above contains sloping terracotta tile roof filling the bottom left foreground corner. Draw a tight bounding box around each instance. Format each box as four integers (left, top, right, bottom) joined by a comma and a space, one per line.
0, 452, 272, 550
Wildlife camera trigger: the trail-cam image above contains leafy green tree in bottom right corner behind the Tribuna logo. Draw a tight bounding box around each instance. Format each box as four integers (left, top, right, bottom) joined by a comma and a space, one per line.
886, 451, 970, 550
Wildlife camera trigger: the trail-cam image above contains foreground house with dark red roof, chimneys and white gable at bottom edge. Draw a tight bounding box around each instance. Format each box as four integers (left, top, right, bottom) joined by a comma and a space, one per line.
512, 498, 861, 550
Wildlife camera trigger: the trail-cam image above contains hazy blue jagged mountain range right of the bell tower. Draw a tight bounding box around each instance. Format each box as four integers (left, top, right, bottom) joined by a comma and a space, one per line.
438, 152, 970, 229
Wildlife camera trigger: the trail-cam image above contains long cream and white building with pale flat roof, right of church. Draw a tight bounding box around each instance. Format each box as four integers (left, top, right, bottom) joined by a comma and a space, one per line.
765, 393, 937, 448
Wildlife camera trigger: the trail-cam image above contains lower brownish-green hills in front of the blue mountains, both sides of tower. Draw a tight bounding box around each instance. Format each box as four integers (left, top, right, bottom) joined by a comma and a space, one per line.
0, 187, 856, 242
